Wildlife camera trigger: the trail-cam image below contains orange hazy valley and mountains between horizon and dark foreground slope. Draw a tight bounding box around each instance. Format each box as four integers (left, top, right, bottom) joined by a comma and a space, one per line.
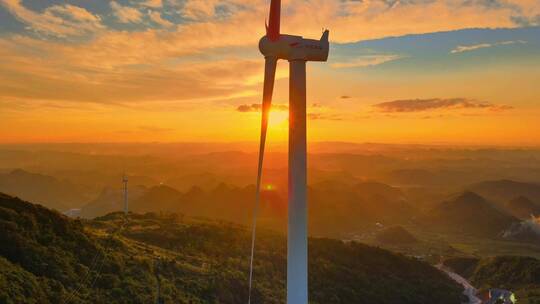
0, 143, 540, 236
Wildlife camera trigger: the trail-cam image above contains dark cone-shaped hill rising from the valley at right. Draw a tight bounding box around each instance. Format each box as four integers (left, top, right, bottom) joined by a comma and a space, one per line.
422, 191, 519, 237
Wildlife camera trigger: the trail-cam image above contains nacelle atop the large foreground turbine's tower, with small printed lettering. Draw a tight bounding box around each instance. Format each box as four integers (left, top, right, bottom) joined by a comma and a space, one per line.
259, 30, 330, 61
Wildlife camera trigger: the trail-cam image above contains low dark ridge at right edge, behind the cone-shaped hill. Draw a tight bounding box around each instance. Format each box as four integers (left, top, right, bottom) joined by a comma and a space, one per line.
468, 180, 540, 205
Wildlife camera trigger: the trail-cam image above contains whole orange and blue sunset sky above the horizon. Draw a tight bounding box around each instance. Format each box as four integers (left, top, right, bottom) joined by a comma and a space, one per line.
0, 0, 540, 146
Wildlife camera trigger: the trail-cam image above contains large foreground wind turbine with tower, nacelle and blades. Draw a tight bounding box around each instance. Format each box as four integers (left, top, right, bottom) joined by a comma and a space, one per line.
248, 0, 329, 304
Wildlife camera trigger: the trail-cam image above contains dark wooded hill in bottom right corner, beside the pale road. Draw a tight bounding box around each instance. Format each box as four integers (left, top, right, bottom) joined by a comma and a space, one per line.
444, 256, 540, 303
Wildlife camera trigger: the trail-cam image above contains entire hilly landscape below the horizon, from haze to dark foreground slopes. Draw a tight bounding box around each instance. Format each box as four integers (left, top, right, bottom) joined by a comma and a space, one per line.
0, 145, 540, 303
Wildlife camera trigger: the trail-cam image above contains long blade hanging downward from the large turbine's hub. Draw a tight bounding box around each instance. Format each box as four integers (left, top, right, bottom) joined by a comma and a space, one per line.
248, 57, 277, 304
